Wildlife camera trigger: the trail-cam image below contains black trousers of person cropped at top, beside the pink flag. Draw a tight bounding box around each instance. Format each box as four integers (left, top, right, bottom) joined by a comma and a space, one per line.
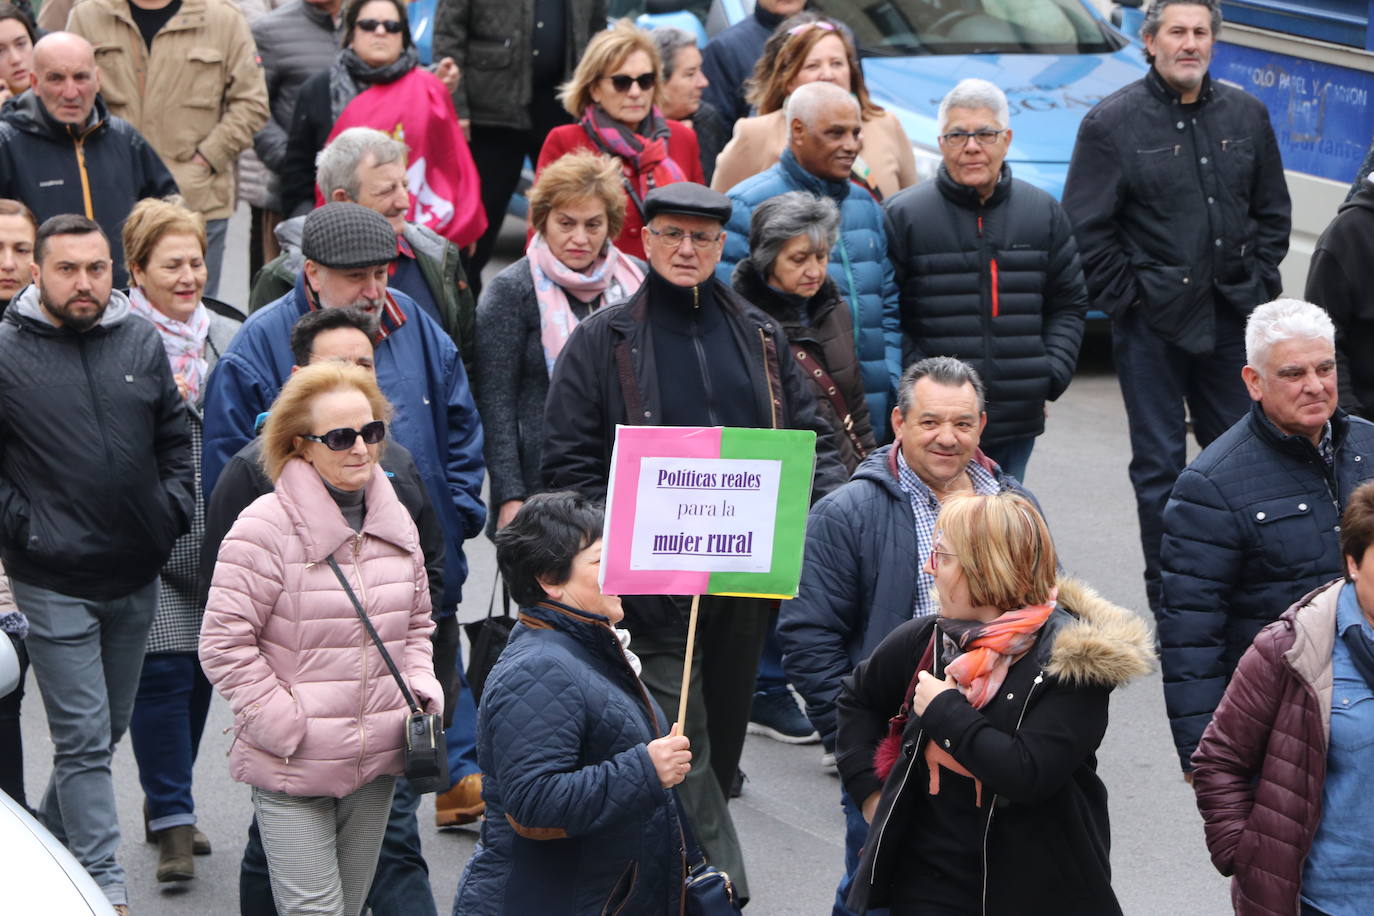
464, 87, 573, 295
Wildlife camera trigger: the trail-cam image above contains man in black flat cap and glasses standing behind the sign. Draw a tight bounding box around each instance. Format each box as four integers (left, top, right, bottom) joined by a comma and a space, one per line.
544, 181, 845, 897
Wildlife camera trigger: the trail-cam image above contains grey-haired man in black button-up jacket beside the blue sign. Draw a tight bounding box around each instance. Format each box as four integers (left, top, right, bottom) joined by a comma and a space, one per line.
1063, 0, 1292, 614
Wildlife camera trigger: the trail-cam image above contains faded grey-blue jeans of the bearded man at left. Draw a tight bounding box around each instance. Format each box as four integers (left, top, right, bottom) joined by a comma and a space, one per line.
12, 580, 158, 905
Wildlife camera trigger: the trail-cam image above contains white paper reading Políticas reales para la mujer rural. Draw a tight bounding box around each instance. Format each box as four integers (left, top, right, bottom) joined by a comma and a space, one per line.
629, 457, 782, 573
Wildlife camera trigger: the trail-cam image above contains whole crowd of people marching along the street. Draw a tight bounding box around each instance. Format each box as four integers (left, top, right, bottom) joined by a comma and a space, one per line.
0, 0, 1374, 916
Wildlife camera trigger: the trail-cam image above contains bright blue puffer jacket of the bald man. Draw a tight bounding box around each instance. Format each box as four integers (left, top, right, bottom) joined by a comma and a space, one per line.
716, 150, 901, 433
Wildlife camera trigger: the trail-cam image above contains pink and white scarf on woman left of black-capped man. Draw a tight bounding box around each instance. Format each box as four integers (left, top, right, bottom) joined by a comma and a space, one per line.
525, 232, 644, 375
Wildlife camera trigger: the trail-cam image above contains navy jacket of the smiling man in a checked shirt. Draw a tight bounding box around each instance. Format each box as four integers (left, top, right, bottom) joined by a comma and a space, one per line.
778, 444, 1035, 750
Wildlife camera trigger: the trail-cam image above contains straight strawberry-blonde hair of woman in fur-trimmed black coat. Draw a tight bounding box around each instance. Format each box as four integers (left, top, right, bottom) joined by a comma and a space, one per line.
936, 490, 1058, 611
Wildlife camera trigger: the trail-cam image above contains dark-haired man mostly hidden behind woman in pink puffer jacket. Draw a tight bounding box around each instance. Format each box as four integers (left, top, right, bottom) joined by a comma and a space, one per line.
199, 309, 467, 916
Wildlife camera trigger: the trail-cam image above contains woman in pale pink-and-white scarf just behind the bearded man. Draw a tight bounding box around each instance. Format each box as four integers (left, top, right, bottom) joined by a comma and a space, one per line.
122, 198, 243, 882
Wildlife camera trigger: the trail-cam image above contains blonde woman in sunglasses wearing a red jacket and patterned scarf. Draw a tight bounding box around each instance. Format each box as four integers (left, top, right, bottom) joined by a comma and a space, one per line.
532, 19, 706, 258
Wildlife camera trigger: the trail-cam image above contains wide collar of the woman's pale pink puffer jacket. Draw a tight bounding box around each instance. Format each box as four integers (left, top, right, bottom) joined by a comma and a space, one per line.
276, 459, 419, 563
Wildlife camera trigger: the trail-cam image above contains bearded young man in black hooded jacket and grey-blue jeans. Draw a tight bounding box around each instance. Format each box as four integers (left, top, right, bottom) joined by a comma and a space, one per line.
0, 214, 195, 913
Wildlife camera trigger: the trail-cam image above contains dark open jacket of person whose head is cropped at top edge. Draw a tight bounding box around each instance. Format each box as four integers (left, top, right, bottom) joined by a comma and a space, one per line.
434, 0, 606, 130
